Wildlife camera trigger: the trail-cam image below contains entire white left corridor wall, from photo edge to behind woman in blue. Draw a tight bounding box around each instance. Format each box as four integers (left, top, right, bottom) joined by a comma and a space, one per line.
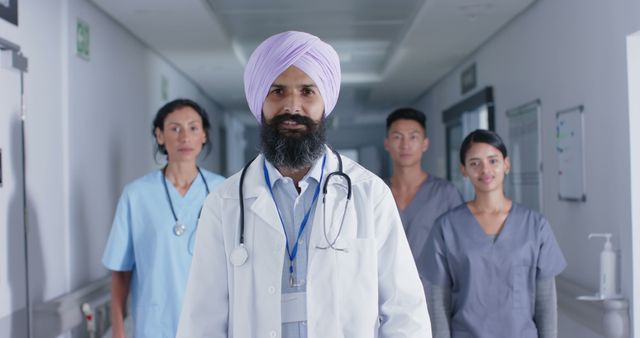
0, 0, 221, 337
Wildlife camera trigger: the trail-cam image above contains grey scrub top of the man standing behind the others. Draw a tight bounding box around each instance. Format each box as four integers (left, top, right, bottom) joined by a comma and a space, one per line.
386, 174, 464, 262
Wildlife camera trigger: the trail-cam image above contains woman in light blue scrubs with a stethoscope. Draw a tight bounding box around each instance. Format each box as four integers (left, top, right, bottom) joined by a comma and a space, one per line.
102, 99, 223, 338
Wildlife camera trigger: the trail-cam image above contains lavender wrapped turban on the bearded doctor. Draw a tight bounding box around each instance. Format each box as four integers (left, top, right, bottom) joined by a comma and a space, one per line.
244, 31, 341, 121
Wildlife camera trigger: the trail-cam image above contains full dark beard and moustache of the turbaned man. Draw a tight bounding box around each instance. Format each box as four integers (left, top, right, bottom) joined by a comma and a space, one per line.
260, 114, 326, 170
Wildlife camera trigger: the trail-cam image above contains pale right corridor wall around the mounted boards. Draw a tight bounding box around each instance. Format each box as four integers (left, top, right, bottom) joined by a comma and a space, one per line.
416, 0, 640, 337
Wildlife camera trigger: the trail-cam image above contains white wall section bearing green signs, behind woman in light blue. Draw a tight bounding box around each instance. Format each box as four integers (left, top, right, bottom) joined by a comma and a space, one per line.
66, 0, 224, 288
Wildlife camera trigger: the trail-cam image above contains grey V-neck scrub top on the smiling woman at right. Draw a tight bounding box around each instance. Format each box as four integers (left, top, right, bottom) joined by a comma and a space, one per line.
421, 202, 567, 338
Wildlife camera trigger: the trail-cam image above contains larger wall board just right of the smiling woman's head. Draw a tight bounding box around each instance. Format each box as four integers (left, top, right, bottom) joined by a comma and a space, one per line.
506, 100, 542, 212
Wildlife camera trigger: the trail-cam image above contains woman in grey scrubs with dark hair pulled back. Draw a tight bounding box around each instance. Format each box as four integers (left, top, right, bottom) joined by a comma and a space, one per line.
419, 130, 566, 338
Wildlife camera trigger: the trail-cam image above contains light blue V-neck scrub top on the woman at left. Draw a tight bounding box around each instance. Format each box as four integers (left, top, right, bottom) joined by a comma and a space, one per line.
102, 170, 224, 338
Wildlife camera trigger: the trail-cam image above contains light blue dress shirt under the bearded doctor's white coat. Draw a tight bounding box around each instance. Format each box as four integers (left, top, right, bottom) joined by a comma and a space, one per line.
266, 157, 322, 338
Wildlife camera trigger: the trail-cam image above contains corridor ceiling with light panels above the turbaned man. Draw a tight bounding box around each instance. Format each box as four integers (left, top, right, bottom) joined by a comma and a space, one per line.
90, 0, 535, 114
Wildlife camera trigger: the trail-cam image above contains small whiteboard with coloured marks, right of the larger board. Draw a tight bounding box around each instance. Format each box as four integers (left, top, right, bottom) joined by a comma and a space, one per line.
556, 105, 587, 202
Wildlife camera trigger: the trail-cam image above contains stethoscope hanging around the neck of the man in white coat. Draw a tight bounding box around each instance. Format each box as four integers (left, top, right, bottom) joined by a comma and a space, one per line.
229, 149, 351, 266
